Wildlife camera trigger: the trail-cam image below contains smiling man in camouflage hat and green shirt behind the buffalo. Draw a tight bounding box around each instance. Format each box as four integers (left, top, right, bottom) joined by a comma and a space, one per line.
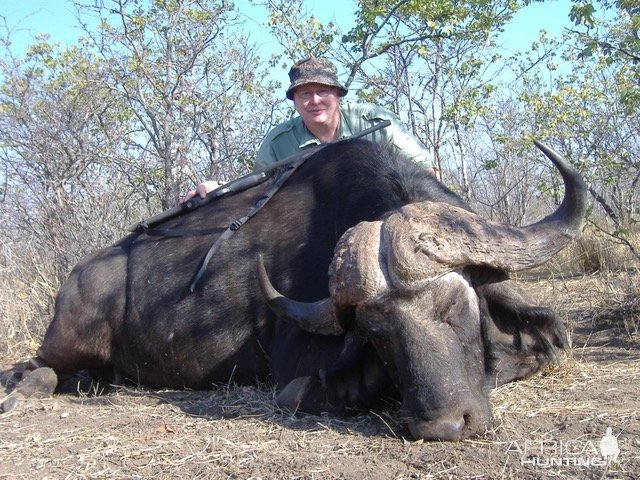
183, 58, 435, 201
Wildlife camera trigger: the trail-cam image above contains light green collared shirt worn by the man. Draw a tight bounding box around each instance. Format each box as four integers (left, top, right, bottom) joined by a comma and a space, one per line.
253, 103, 432, 171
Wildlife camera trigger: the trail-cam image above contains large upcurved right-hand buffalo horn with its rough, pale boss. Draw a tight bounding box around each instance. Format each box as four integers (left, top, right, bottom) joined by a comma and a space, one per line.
382, 142, 586, 283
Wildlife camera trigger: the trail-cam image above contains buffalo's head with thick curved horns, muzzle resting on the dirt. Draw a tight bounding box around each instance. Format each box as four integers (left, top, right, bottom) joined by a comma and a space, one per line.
260, 144, 585, 440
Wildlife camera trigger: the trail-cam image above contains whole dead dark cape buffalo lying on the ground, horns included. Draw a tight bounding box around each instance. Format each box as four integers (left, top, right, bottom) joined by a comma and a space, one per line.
5, 140, 585, 440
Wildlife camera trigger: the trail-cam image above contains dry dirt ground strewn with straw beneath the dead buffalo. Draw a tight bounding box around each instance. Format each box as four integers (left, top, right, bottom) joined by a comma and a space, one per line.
0, 277, 640, 480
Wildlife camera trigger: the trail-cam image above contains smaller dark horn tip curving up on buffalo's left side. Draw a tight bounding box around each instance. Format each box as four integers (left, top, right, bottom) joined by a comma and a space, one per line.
258, 254, 344, 335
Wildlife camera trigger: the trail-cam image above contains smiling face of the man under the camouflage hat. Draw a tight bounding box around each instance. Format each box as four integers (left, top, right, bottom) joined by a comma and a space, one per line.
293, 83, 340, 130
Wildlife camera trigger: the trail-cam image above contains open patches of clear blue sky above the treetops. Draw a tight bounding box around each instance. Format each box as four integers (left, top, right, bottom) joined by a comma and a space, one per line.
0, 0, 571, 57
